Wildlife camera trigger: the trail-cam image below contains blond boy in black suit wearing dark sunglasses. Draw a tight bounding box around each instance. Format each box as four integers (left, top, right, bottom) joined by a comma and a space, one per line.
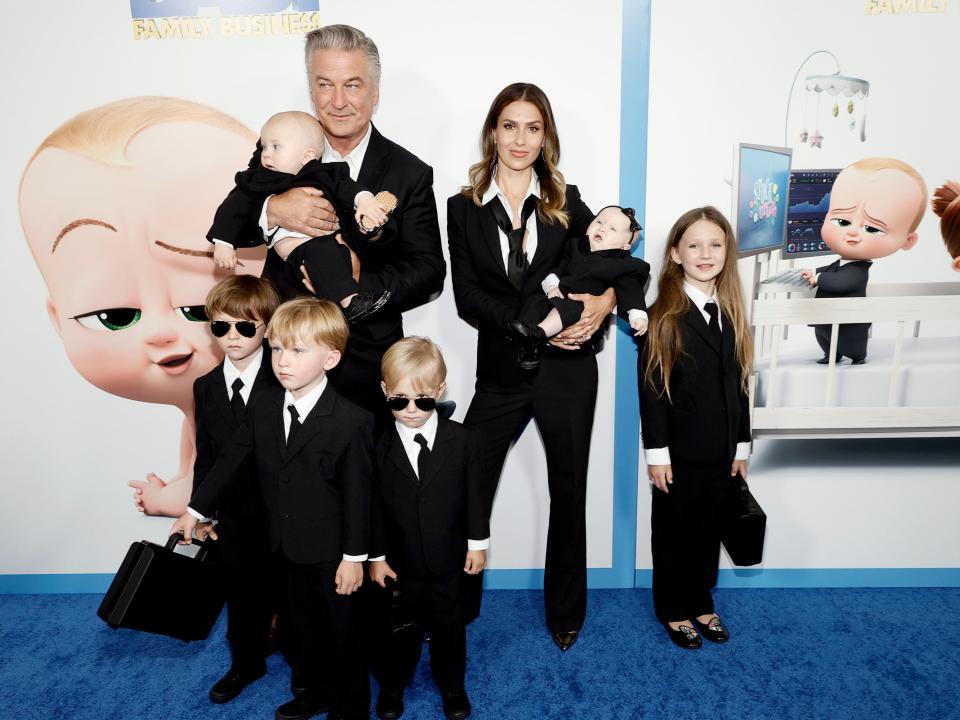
370, 337, 490, 720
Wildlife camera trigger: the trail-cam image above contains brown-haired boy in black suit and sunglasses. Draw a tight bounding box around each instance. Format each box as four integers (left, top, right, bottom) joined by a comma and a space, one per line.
186, 275, 280, 703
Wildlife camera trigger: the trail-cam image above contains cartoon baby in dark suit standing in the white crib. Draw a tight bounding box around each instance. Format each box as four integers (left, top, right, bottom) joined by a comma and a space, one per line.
802, 157, 927, 365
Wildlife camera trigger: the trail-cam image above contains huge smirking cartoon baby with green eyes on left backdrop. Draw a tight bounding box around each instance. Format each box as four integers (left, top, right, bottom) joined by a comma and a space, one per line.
19, 97, 265, 517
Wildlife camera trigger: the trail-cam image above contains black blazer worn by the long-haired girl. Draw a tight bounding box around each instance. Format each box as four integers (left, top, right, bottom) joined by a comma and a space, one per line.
638, 302, 750, 462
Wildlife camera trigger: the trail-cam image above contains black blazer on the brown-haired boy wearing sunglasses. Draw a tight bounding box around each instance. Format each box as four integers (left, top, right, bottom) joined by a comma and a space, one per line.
193, 344, 278, 545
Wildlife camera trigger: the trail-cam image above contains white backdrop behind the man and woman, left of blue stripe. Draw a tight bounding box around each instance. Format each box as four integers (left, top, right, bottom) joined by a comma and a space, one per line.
0, 0, 621, 574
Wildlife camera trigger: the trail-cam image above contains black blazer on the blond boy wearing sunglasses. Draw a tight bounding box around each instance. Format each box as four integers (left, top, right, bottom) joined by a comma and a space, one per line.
370, 418, 490, 577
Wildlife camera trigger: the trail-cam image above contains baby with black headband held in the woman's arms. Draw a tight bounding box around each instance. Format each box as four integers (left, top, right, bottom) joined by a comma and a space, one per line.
510, 205, 650, 370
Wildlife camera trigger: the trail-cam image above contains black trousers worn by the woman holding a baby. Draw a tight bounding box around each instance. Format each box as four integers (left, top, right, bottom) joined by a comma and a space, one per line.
464, 348, 597, 632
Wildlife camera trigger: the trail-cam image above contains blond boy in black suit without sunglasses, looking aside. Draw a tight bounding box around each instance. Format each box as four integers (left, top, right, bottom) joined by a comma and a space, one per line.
171, 297, 373, 720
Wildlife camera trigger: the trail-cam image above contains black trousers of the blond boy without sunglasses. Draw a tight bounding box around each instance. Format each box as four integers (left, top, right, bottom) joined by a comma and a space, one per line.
274, 551, 370, 720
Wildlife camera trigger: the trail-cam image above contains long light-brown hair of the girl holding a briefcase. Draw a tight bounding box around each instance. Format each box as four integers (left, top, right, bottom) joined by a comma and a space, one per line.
644, 205, 753, 398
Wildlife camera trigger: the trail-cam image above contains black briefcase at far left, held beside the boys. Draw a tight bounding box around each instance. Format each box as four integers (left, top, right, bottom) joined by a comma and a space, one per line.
97, 533, 226, 642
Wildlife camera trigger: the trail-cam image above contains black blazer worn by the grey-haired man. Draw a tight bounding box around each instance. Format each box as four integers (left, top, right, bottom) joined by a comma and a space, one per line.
250, 127, 447, 365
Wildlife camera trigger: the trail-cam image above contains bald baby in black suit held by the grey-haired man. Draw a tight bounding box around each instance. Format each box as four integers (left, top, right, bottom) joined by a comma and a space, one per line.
207, 112, 397, 322
